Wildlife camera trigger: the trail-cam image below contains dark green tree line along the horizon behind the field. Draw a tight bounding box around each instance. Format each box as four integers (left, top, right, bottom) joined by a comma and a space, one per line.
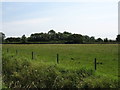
0, 30, 120, 44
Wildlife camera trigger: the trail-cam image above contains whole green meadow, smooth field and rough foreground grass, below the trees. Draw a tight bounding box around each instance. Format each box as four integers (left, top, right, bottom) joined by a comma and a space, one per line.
2, 44, 118, 88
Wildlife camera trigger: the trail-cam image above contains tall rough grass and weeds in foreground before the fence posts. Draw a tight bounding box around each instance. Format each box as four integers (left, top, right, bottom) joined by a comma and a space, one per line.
2, 53, 118, 89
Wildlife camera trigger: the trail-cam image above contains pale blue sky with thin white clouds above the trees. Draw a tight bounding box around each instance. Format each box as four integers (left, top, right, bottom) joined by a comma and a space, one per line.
0, 0, 118, 39
